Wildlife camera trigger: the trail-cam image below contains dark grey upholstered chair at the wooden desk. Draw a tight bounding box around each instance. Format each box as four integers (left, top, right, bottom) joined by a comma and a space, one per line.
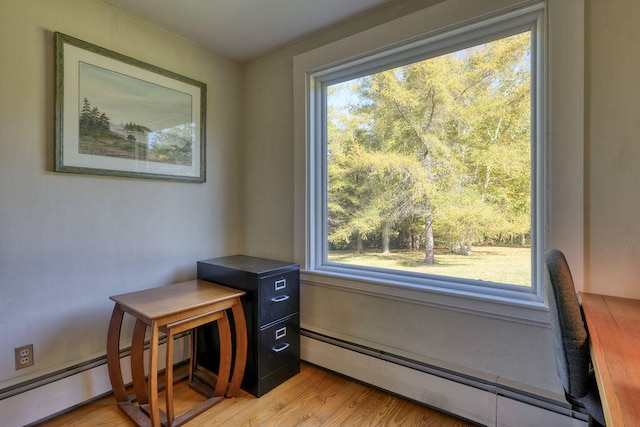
546, 249, 605, 426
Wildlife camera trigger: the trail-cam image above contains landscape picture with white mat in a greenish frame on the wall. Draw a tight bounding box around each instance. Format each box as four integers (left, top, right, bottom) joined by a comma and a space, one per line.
54, 33, 207, 182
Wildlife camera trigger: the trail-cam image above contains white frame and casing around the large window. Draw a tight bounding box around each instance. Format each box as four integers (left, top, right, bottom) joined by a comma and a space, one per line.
294, 0, 584, 324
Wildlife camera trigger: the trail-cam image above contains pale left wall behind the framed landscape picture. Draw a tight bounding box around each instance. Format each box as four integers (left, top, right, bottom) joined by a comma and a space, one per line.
0, 0, 242, 397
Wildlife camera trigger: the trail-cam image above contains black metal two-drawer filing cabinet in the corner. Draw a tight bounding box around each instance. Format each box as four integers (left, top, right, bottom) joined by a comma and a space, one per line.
197, 255, 300, 397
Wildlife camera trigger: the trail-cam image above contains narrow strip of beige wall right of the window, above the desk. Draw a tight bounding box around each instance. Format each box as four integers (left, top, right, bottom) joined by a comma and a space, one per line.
585, 0, 640, 298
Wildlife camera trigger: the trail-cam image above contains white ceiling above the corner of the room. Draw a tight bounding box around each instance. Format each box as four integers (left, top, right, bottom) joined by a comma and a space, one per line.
104, 0, 394, 61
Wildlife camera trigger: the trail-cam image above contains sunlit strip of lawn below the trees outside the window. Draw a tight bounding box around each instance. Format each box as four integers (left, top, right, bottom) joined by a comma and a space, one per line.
329, 246, 531, 286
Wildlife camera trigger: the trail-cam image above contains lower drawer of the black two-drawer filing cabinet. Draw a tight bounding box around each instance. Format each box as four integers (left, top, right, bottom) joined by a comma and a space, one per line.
260, 314, 300, 377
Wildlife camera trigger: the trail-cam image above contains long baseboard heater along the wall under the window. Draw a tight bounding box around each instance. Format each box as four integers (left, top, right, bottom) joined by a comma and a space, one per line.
300, 329, 587, 427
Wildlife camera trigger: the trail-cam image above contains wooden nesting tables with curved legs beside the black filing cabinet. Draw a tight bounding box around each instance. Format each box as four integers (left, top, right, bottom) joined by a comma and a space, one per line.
107, 280, 247, 427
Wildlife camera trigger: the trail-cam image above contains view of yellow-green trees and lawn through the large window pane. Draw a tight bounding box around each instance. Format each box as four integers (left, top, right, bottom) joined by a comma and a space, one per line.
325, 31, 532, 286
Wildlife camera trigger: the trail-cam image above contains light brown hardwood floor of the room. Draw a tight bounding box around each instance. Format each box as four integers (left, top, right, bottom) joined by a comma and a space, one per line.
36, 363, 474, 427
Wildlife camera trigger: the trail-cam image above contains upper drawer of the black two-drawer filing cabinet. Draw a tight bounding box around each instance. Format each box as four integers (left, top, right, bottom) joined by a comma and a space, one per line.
258, 270, 300, 325
